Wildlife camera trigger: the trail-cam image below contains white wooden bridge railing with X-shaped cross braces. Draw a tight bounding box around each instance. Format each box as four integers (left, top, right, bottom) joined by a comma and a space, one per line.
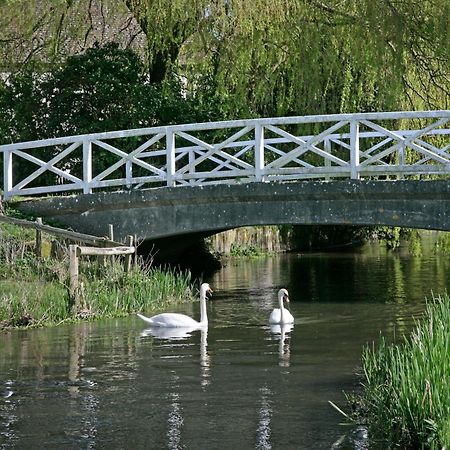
0, 110, 450, 200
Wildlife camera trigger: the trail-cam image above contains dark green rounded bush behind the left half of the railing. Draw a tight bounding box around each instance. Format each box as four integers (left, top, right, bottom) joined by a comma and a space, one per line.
39, 43, 144, 137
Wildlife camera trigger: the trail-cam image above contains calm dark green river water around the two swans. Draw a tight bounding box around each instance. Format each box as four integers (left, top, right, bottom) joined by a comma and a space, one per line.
0, 247, 450, 450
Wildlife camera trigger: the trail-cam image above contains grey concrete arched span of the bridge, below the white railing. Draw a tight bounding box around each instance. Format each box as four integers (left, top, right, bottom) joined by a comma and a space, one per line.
20, 180, 450, 260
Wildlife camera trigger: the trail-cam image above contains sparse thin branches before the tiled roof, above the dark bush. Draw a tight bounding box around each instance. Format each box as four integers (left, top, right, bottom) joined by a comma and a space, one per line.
0, 0, 145, 73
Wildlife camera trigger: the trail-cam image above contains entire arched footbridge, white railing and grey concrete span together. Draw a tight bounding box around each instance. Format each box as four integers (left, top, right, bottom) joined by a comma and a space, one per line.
0, 111, 450, 250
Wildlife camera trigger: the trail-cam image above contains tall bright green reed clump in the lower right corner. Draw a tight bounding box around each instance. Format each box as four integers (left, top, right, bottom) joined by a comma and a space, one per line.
357, 295, 450, 450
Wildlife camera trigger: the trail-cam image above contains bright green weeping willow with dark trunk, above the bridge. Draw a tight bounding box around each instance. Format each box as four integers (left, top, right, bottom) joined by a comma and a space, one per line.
121, 0, 450, 114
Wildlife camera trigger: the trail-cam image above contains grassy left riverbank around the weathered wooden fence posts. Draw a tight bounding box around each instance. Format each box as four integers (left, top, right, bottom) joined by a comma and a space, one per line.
0, 220, 196, 329
